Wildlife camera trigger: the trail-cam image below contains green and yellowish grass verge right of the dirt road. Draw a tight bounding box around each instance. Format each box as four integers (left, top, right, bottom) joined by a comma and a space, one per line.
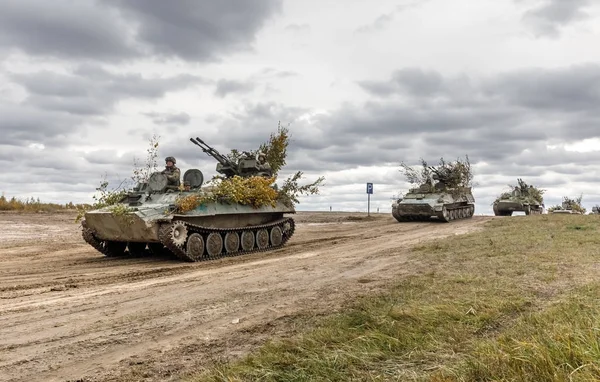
190, 215, 600, 382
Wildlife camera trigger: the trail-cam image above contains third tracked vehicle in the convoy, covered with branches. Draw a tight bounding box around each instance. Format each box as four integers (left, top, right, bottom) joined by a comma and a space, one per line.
493, 178, 544, 216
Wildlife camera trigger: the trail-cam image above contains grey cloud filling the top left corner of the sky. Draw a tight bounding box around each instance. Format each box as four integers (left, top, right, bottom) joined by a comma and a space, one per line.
0, 0, 138, 61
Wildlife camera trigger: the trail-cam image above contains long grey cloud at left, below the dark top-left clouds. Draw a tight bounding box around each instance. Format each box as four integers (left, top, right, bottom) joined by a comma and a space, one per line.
11, 65, 206, 115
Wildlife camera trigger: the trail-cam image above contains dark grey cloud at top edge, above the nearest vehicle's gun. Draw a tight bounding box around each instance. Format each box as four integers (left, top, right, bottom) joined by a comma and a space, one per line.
104, 0, 281, 61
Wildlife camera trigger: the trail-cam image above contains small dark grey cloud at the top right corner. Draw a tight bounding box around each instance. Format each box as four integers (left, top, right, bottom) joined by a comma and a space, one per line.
523, 0, 591, 38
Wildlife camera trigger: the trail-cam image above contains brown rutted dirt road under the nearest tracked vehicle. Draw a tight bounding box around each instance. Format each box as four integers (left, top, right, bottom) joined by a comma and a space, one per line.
0, 212, 492, 381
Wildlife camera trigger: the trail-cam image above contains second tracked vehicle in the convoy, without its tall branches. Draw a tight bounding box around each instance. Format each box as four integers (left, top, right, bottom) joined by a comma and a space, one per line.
392, 163, 475, 222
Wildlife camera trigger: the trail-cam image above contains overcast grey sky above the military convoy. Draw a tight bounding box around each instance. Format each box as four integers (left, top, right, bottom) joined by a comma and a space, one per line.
0, 0, 600, 214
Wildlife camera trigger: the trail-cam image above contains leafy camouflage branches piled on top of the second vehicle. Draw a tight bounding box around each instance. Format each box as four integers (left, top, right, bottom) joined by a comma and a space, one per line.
400, 156, 473, 190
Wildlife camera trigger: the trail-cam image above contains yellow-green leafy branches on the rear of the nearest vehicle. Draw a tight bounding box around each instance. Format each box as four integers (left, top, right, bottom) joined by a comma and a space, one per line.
175, 124, 325, 213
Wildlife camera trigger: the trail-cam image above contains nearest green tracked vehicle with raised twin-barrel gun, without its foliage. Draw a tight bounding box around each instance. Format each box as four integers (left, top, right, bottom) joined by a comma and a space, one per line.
82, 138, 295, 261
